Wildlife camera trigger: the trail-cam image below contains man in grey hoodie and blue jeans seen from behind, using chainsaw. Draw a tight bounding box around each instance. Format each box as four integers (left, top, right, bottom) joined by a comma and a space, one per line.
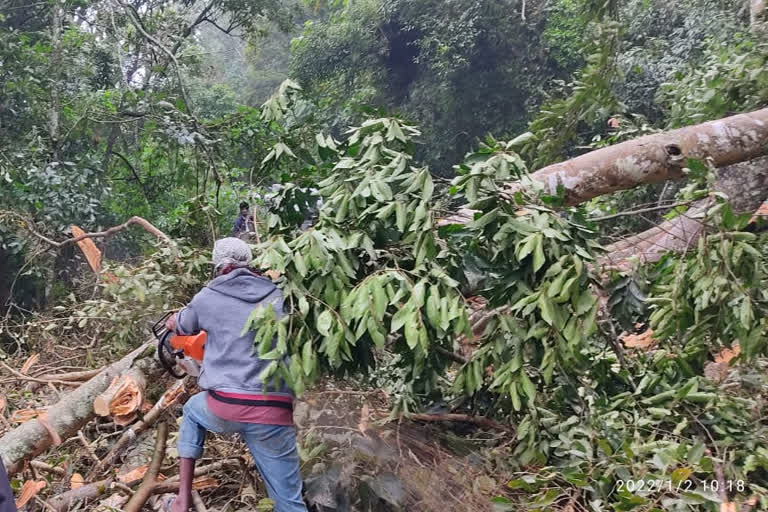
165, 238, 307, 512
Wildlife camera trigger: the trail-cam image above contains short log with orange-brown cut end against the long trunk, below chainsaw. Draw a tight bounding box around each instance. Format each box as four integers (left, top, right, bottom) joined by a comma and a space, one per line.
93, 368, 147, 425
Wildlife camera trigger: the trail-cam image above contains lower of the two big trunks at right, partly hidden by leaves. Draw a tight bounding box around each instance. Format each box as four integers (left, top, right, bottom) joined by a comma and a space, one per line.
601, 157, 768, 270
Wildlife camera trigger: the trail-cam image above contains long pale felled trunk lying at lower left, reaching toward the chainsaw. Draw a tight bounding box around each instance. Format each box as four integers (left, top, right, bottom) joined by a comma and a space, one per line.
0, 341, 153, 475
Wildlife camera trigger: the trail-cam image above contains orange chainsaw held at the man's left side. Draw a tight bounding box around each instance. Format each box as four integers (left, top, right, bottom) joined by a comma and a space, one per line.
152, 312, 207, 379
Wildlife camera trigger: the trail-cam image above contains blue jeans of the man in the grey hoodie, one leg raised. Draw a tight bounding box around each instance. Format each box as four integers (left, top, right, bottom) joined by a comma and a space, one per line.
178, 391, 307, 512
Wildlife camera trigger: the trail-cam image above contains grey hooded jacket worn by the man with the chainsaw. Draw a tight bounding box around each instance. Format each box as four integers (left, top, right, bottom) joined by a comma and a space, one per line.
176, 268, 293, 396
